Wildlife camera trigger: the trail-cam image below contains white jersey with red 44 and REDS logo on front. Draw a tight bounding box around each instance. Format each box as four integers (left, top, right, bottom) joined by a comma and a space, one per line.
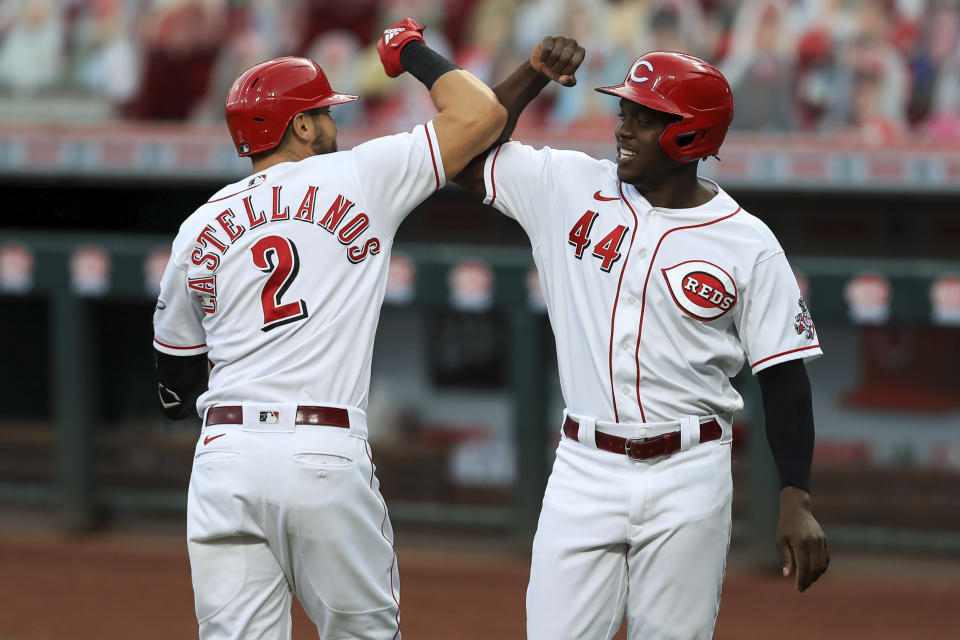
484, 142, 821, 430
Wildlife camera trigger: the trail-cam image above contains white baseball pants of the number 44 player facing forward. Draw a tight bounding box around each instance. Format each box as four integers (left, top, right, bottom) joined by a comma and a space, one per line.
527, 423, 733, 640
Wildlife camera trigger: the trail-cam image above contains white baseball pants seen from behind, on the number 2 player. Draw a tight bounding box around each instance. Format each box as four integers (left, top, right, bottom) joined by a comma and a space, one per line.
187, 410, 400, 640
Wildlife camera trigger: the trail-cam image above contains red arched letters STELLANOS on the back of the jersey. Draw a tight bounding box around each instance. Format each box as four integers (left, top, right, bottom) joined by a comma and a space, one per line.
190, 185, 381, 271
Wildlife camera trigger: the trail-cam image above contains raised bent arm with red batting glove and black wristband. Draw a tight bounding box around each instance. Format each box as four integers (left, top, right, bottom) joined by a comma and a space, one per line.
377, 18, 507, 180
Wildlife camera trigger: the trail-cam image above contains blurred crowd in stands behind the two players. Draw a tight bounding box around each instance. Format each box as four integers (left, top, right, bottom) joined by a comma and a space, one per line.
0, 0, 960, 144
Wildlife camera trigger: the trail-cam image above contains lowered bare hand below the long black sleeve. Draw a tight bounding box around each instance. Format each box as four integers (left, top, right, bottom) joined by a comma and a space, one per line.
777, 487, 830, 591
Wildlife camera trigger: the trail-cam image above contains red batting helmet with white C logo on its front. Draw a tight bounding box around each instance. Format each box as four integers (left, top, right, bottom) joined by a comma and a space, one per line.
597, 51, 733, 162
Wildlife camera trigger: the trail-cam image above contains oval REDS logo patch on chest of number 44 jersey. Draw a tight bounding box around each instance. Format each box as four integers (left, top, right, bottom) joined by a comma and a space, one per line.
661, 260, 737, 322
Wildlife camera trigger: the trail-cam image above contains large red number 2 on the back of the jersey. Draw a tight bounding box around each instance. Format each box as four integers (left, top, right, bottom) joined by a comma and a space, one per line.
250, 236, 307, 331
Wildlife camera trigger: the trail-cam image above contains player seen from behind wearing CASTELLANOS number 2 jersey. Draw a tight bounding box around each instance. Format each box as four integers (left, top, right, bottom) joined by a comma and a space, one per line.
153, 19, 506, 640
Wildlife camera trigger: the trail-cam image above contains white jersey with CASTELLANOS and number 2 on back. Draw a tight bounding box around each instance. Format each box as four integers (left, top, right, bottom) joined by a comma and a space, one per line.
154, 122, 446, 415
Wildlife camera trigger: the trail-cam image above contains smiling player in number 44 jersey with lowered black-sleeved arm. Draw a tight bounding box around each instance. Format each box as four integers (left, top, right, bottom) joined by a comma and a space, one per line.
461, 38, 829, 640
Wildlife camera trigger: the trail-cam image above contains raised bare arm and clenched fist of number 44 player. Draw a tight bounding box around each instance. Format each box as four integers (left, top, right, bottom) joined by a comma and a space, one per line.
456, 36, 585, 198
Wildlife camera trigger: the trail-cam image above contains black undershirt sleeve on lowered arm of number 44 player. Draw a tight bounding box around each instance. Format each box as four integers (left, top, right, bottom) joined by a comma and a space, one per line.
757, 360, 814, 492
